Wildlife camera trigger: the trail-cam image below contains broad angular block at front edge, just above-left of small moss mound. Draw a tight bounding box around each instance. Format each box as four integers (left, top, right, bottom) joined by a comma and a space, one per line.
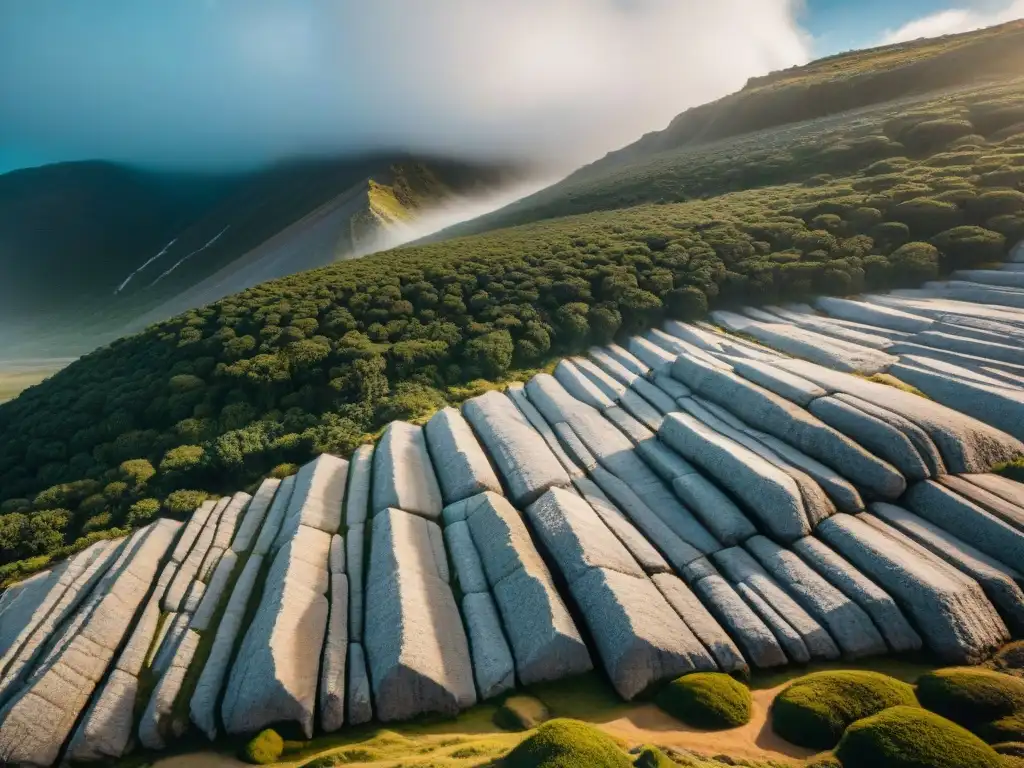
569, 569, 716, 699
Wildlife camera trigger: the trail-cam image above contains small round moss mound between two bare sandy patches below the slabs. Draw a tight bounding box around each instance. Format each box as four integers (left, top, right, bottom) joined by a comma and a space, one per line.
656, 672, 753, 730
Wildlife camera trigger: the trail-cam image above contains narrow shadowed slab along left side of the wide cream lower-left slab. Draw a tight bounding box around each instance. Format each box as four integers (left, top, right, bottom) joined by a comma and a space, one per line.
188, 557, 270, 741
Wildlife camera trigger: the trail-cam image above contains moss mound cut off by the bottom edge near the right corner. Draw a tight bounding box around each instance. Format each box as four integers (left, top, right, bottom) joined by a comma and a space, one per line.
836, 707, 1002, 768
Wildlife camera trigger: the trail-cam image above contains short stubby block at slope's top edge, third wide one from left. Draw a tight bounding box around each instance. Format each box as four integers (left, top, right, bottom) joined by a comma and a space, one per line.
424, 408, 502, 505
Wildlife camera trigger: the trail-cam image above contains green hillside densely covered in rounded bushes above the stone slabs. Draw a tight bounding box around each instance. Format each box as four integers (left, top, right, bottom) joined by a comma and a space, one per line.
0, 28, 1024, 579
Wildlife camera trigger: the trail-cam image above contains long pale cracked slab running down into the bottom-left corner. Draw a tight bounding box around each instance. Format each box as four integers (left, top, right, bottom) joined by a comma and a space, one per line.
0, 519, 181, 766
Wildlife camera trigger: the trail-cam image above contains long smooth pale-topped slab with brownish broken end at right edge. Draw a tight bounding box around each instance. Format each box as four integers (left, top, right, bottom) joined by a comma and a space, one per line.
776, 360, 1024, 474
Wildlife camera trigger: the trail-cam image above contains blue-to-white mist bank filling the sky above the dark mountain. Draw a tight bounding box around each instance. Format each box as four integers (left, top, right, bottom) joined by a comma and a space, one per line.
0, 0, 809, 170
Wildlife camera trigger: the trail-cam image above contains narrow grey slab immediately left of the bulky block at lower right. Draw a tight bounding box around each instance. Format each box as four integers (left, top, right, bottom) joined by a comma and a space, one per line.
792, 537, 922, 653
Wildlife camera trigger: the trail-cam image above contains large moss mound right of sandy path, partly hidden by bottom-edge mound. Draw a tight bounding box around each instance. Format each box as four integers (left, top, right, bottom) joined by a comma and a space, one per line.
771, 670, 916, 750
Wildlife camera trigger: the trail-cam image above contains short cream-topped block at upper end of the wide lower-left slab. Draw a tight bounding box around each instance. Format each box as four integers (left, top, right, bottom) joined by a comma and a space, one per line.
274, 454, 348, 547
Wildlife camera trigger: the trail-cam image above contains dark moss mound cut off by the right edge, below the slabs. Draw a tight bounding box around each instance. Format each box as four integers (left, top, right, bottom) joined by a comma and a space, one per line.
918, 667, 1024, 743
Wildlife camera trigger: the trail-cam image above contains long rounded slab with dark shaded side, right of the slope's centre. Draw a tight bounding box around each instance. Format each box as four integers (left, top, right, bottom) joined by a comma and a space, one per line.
672, 356, 906, 499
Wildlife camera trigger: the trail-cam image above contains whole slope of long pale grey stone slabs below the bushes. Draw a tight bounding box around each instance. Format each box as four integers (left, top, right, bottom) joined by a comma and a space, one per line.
0, 257, 1024, 766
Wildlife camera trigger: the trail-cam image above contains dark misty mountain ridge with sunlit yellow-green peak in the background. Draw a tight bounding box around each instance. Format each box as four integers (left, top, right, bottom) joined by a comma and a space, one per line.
0, 155, 517, 358
